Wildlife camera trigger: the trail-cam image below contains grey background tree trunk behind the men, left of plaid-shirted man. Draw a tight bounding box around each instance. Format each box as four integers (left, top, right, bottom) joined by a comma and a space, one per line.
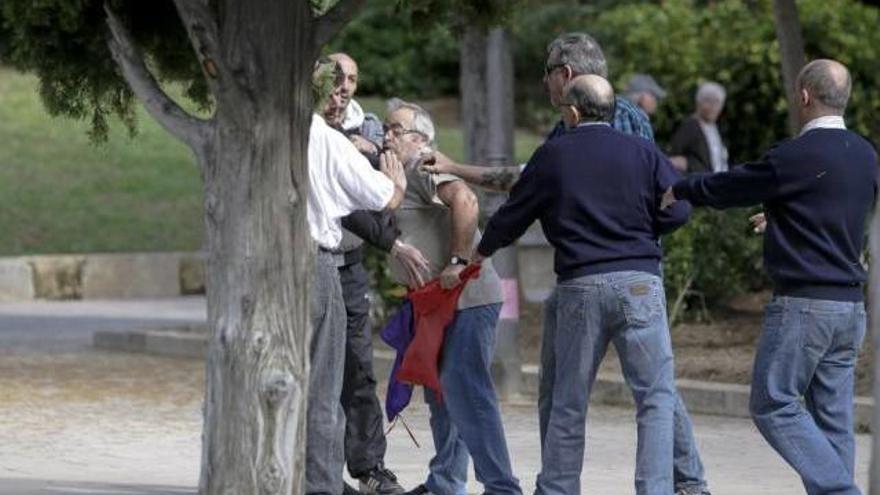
459, 25, 522, 398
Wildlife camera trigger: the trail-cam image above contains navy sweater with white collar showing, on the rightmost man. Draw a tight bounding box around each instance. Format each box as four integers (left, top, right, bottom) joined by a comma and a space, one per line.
673, 129, 877, 301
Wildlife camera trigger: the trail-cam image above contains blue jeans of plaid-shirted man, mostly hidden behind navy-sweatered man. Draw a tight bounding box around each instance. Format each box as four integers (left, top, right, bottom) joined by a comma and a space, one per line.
538, 290, 706, 490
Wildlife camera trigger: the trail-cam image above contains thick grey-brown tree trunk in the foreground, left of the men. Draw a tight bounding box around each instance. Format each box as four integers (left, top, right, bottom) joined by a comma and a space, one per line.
199, 0, 317, 495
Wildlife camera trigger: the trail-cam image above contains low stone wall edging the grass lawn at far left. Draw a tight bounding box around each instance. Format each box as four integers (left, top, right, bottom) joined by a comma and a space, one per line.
0, 252, 205, 301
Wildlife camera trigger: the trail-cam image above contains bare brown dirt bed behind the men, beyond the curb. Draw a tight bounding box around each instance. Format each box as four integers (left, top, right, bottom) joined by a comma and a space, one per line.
520, 293, 873, 396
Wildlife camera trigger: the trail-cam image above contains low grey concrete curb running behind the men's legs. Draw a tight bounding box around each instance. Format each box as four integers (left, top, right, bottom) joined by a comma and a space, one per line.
94, 325, 874, 431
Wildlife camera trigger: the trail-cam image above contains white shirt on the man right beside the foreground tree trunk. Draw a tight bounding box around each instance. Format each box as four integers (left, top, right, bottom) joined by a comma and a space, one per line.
308, 114, 394, 249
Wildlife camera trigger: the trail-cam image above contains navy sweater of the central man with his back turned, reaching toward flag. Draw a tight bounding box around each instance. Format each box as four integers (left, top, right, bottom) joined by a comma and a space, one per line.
477, 125, 690, 280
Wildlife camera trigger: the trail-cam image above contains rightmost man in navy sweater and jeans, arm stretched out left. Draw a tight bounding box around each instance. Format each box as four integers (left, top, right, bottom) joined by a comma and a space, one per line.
664, 60, 877, 495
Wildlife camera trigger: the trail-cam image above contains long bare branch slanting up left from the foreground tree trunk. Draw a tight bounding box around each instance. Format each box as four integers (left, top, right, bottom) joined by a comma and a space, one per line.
104, 4, 211, 153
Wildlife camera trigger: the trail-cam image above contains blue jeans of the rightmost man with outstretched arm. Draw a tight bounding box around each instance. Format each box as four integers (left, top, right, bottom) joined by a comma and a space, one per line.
749, 297, 866, 495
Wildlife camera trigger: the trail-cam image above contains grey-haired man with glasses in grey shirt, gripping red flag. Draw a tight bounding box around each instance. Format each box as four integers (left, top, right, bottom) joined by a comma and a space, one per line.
385, 99, 522, 495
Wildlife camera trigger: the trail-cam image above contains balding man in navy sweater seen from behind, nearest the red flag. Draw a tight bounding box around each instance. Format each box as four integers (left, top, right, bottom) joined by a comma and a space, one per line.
475, 75, 690, 495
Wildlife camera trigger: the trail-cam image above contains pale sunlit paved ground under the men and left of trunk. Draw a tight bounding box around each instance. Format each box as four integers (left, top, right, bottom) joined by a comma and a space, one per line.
0, 299, 869, 495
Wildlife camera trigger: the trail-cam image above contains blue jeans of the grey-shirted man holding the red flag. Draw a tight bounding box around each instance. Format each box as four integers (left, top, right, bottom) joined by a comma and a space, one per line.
425, 304, 522, 495
